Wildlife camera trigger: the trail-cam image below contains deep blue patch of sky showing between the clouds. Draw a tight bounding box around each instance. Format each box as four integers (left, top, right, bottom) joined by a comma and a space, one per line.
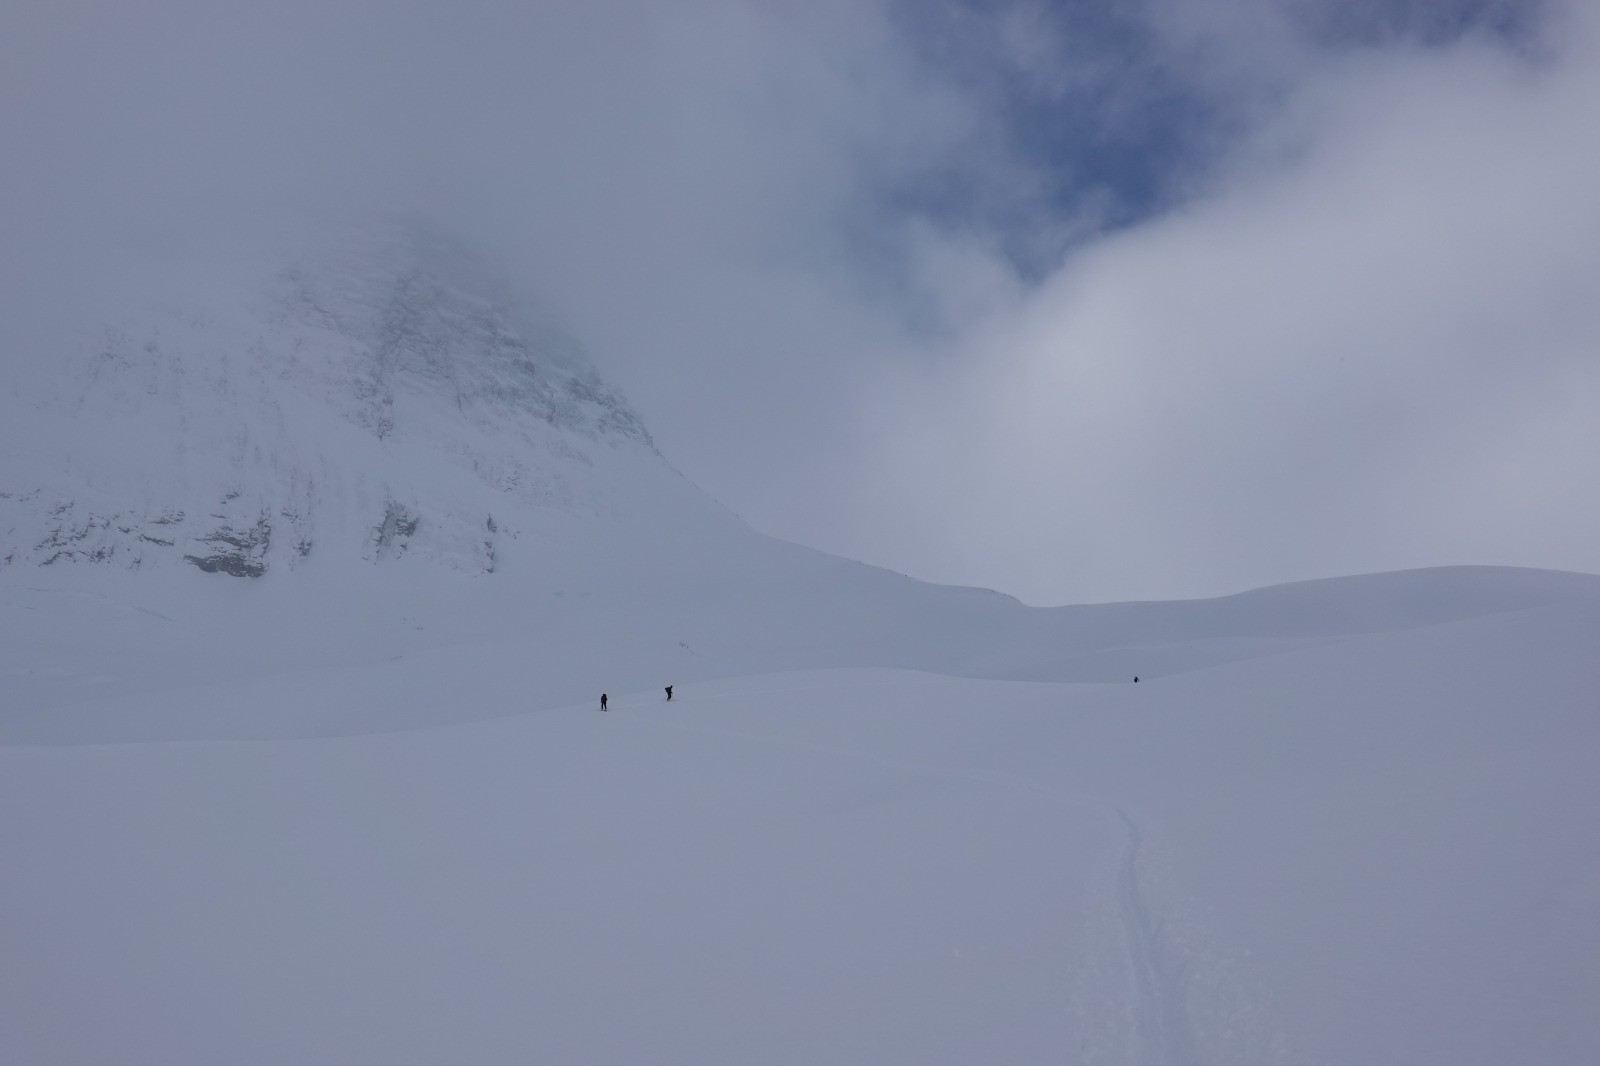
882, 0, 1550, 279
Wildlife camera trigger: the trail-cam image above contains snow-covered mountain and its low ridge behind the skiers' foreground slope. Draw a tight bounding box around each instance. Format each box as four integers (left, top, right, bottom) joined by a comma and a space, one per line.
0, 222, 1594, 735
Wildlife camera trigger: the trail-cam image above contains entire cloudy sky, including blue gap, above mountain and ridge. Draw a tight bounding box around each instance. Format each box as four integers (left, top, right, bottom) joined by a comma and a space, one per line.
0, 0, 1600, 603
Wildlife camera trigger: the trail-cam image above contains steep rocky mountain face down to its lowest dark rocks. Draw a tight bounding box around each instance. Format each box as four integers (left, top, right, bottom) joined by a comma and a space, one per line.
0, 217, 674, 578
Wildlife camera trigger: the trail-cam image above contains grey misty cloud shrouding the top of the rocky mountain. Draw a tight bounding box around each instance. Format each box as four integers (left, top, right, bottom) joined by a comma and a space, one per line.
0, 0, 978, 460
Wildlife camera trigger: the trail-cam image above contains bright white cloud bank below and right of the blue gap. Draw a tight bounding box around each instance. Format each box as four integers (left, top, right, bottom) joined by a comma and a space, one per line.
825, 0, 1600, 602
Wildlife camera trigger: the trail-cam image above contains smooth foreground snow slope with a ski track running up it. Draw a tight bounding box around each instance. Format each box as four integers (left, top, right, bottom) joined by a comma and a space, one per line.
0, 585, 1600, 1066
